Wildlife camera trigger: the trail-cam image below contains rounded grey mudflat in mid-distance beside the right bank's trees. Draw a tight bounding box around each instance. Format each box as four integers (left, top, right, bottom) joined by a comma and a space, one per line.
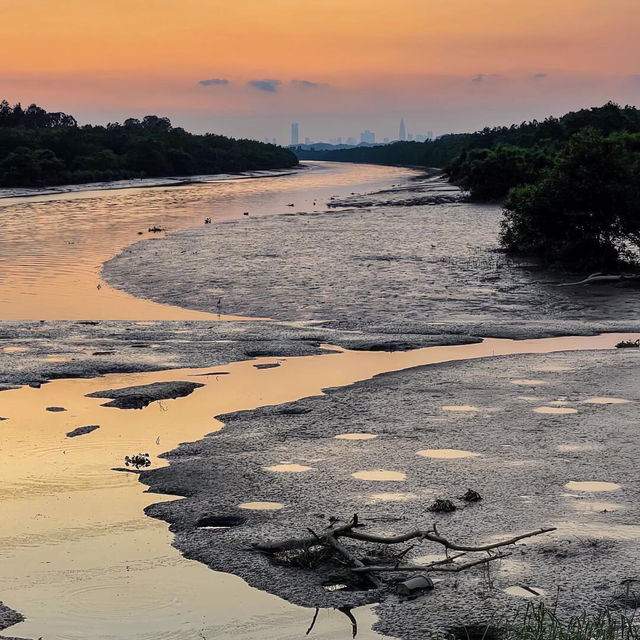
103, 178, 640, 335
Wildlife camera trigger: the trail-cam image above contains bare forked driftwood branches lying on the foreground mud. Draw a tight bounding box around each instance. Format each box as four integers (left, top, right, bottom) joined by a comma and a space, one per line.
254, 514, 555, 588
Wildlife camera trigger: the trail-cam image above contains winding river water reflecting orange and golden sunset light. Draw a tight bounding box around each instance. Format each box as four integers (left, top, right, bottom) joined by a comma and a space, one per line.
0, 163, 640, 640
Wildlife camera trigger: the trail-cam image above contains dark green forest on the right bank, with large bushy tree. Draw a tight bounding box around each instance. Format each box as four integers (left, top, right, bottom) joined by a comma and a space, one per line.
306, 102, 640, 270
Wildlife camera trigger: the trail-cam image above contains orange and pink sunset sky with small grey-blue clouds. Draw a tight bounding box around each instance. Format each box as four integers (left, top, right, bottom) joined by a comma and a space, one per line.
0, 0, 640, 143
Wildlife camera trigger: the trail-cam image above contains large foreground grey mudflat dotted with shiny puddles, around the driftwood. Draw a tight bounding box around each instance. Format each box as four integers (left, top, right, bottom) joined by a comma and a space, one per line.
142, 350, 640, 638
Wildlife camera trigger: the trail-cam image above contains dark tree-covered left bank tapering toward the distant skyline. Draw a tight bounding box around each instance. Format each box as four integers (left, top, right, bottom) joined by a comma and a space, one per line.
0, 101, 298, 187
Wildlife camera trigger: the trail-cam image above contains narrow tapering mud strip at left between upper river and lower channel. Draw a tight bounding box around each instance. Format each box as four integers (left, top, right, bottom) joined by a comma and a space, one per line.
0, 321, 478, 384
